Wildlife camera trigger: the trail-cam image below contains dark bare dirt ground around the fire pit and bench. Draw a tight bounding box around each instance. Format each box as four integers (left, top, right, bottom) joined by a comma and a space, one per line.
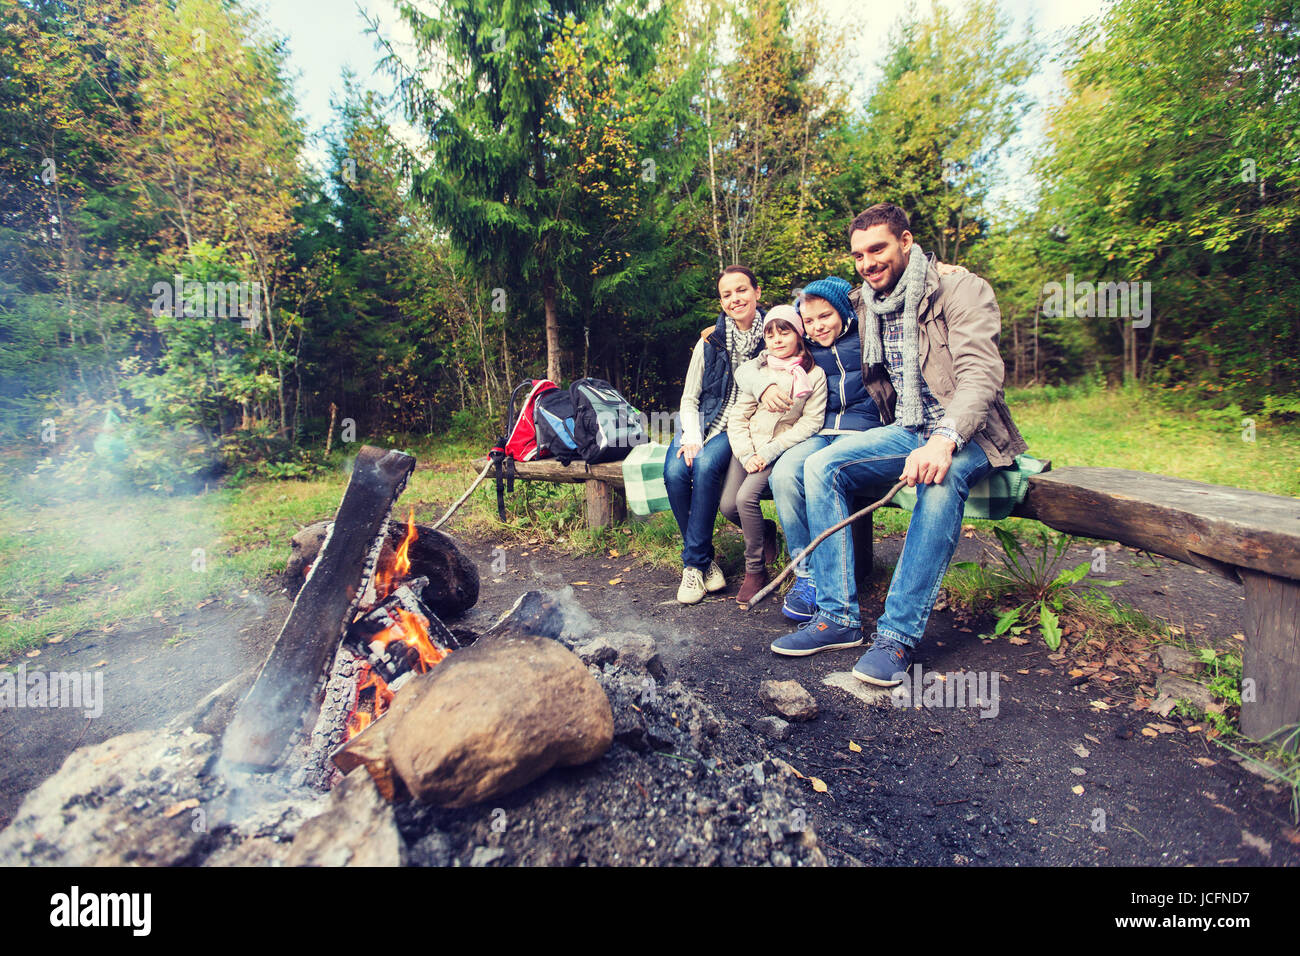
0, 529, 1300, 866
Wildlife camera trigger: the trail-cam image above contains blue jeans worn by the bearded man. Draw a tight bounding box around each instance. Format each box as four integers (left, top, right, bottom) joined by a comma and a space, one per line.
803, 425, 992, 648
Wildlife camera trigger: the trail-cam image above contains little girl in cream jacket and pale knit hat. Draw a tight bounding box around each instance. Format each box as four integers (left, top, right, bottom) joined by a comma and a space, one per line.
722, 306, 827, 604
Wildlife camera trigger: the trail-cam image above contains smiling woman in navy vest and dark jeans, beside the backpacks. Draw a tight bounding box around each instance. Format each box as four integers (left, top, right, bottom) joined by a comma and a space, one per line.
663, 265, 763, 604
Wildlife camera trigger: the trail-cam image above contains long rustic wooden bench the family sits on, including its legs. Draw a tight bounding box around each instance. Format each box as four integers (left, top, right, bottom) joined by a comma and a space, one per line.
475, 459, 1300, 739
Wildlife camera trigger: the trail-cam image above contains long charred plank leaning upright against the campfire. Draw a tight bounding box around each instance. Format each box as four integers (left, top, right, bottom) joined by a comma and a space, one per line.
222, 445, 415, 771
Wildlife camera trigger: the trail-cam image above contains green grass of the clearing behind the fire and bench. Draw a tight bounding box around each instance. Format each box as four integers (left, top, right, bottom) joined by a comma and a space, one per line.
0, 389, 1300, 659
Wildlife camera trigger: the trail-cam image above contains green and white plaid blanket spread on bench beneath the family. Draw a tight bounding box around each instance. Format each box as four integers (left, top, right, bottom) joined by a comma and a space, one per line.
623, 444, 1047, 522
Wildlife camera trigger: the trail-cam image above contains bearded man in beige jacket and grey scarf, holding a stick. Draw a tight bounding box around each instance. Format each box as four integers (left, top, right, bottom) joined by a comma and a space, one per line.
771, 203, 1027, 687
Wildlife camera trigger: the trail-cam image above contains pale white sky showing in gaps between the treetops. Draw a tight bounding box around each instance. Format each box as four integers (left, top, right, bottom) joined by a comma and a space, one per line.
259, 0, 1106, 210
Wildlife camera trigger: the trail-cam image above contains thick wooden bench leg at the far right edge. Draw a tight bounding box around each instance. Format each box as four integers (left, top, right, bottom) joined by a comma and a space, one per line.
1240, 568, 1300, 749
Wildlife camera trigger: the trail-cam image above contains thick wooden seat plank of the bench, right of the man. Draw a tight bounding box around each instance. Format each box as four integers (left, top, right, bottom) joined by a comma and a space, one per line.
1013, 467, 1300, 581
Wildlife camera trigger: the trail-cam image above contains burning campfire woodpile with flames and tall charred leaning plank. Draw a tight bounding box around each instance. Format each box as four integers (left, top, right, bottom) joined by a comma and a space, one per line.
222, 446, 478, 773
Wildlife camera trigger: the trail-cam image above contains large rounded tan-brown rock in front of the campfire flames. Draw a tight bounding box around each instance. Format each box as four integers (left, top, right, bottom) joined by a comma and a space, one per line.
382, 633, 614, 806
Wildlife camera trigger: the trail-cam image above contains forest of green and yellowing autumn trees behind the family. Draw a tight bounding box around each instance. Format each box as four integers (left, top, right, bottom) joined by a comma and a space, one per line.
0, 0, 1300, 492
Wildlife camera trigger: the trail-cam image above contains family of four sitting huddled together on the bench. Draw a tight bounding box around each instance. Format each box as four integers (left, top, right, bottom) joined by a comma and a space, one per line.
663, 203, 1027, 687
